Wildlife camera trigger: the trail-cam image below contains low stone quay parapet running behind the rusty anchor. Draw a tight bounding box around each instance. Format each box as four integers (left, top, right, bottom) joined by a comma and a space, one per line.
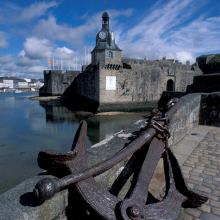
0, 94, 201, 220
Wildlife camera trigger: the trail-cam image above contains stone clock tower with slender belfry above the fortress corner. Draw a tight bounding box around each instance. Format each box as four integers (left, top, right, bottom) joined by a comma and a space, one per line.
91, 12, 121, 67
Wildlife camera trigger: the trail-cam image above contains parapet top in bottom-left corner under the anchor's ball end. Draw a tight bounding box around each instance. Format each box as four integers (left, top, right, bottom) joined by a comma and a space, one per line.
0, 176, 68, 220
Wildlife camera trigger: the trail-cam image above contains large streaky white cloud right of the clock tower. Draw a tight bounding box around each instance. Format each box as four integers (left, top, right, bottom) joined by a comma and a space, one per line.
116, 0, 220, 62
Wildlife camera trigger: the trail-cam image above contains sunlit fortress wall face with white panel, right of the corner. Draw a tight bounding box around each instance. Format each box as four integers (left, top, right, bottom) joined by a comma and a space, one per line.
99, 61, 197, 104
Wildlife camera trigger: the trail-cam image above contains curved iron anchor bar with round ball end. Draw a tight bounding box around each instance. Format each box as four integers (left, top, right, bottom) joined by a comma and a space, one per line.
34, 127, 160, 200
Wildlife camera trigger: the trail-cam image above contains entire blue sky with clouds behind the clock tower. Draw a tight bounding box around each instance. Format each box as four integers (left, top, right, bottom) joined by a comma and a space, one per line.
0, 0, 220, 78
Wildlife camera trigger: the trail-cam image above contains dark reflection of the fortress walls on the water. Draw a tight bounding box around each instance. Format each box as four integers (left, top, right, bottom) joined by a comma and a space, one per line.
40, 102, 145, 144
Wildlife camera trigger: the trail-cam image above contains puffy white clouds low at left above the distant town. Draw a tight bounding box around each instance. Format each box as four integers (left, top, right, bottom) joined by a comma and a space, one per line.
0, 40, 80, 78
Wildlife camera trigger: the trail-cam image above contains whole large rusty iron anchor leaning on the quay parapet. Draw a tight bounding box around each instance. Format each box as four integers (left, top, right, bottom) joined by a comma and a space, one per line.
33, 100, 207, 220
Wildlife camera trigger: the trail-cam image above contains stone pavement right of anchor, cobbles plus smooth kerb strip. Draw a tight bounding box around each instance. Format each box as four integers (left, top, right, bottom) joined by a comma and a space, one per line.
173, 126, 220, 220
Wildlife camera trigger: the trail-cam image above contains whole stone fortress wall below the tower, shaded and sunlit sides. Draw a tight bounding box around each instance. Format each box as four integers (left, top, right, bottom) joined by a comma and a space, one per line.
40, 58, 200, 110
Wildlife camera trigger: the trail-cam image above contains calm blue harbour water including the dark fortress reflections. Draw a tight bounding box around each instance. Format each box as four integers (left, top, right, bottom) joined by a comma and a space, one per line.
0, 93, 148, 193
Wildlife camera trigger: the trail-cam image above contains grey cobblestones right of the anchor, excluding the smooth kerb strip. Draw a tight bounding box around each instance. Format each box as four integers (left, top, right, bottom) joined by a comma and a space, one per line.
177, 128, 220, 220
